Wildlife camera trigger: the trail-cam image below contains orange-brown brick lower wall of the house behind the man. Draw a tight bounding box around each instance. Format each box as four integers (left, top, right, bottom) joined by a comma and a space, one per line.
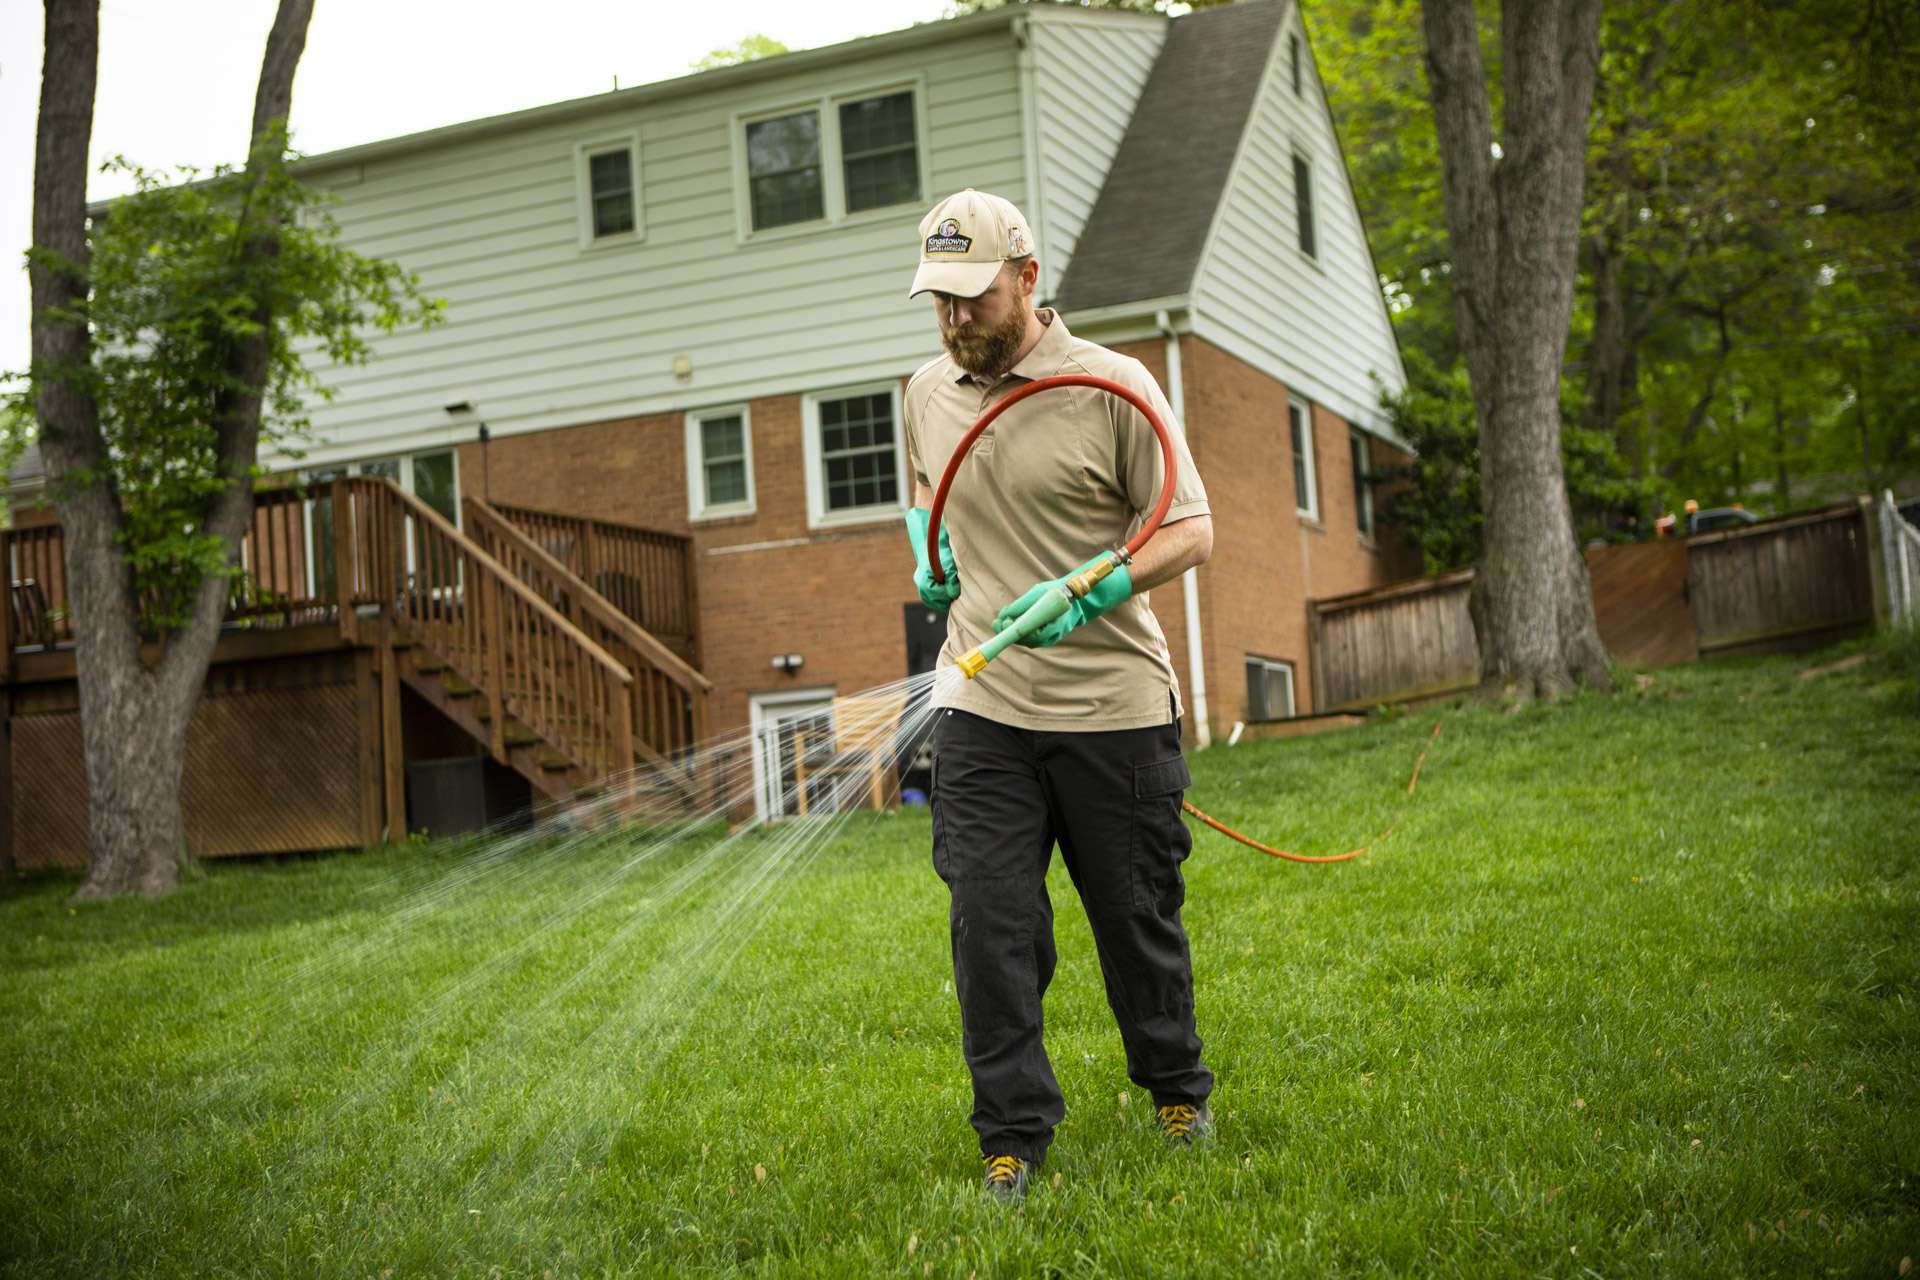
449, 338, 1405, 735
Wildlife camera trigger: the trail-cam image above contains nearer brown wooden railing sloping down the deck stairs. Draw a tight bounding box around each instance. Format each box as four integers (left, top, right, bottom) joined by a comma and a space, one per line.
332, 476, 634, 779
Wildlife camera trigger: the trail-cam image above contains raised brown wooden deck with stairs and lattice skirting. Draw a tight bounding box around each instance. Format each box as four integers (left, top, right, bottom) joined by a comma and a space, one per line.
0, 476, 710, 869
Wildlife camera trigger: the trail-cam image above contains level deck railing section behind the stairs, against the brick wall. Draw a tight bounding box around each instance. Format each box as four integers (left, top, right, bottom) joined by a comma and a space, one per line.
493, 503, 699, 662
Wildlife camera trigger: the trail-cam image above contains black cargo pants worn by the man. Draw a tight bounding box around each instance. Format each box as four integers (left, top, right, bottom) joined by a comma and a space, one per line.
933, 710, 1213, 1161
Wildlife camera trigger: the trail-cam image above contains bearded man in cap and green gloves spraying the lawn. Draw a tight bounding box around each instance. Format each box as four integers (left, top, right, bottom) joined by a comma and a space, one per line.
904, 190, 1213, 1199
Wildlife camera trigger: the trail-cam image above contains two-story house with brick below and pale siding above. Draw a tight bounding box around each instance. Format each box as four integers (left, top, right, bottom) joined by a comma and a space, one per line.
0, 0, 1417, 867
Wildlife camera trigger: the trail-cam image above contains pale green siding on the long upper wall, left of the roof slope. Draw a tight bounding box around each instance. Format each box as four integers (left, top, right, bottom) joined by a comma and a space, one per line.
280, 25, 1027, 462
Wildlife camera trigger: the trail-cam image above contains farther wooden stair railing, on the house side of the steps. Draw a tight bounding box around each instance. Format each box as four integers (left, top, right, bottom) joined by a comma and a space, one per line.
465, 499, 712, 764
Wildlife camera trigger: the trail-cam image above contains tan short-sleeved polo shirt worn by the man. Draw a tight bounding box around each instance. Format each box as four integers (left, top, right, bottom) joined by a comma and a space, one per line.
906, 309, 1208, 731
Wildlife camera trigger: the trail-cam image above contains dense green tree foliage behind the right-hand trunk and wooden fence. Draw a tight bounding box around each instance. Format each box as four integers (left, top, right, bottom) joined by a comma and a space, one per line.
1306, 0, 1920, 510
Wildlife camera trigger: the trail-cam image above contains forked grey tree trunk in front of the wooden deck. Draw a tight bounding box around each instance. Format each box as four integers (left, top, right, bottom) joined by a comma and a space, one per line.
31, 0, 313, 898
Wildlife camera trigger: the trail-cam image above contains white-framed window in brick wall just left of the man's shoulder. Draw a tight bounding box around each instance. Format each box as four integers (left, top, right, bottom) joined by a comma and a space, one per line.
804, 382, 906, 526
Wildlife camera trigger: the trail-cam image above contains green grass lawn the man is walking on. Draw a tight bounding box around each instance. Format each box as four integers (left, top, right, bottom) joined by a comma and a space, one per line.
0, 645, 1920, 1276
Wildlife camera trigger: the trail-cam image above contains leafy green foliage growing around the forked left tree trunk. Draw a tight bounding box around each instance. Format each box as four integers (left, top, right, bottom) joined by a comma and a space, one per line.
8, 136, 444, 628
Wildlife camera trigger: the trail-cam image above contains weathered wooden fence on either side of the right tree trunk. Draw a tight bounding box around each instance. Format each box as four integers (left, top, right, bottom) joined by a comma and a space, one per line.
1308, 503, 1874, 712
